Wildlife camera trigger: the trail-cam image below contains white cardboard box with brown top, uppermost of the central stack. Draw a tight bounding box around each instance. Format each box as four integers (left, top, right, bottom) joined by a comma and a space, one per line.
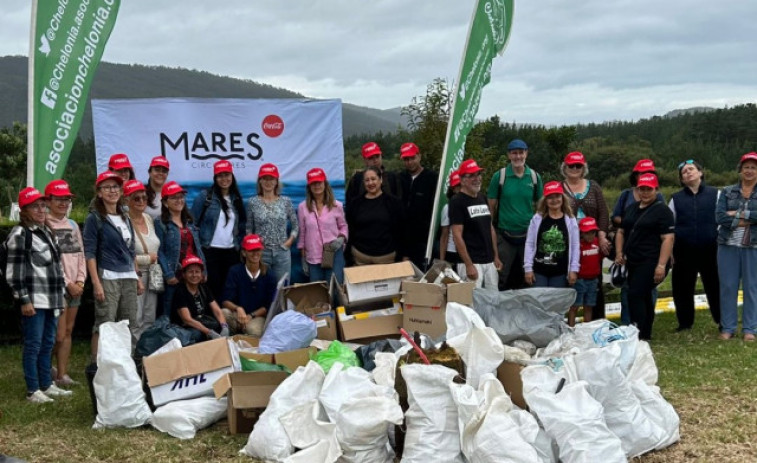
344, 261, 422, 304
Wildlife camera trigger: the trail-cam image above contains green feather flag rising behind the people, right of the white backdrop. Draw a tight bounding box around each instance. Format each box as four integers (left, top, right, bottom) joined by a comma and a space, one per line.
426, 0, 515, 259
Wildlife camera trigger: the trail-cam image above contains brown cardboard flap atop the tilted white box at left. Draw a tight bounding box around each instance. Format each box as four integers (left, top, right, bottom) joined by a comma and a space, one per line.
143, 338, 232, 387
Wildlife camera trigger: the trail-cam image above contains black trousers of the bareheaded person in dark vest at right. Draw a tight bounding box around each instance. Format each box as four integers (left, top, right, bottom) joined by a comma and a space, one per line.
672, 242, 720, 328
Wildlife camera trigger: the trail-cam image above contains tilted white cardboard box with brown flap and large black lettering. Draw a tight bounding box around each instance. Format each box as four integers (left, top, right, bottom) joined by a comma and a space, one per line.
143, 338, 239, 407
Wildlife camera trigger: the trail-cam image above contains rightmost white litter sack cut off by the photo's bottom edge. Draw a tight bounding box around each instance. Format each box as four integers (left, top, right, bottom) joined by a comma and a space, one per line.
523, 381, 627, 463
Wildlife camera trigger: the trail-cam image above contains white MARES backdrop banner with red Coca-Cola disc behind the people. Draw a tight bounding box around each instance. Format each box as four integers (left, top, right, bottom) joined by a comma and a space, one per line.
92, 98, 344, 202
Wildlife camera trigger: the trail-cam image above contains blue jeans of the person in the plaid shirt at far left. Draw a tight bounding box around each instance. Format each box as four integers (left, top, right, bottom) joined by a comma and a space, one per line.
21, 309, 58, 393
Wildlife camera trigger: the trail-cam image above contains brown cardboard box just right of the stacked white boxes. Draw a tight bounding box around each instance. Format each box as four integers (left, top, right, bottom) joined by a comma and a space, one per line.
402, 280, 476, 338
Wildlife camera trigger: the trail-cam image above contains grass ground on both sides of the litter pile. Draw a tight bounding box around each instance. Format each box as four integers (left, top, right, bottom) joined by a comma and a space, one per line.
0, 312, 757, 463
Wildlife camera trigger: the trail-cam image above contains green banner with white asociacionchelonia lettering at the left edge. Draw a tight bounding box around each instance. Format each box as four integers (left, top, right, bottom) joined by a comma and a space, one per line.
27, 0, 121, 191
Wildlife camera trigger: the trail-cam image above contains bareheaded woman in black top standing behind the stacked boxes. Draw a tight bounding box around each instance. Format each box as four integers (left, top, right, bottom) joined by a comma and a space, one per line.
347, 167, 404, 265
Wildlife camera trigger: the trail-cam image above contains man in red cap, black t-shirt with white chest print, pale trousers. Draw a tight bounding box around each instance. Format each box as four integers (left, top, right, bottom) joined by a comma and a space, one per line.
449, 159, 502, 290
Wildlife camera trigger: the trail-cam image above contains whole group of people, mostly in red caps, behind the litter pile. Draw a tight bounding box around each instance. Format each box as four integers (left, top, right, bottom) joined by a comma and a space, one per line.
6, 140, 757, 402
